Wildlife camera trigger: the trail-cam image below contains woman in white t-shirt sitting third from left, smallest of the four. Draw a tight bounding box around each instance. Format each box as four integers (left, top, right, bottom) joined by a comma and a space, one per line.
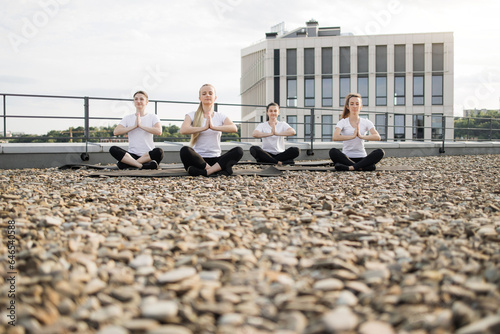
250, 102, 300, 165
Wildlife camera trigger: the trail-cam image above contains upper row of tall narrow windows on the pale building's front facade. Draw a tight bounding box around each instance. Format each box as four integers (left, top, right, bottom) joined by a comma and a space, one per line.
274, 43, 444, 107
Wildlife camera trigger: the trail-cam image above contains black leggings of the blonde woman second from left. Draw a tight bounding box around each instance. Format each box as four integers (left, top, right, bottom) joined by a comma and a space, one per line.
180, 146, 243, 170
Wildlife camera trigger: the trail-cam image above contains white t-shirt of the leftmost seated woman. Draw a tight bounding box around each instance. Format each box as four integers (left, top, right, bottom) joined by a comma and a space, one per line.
120, 114, 160, 156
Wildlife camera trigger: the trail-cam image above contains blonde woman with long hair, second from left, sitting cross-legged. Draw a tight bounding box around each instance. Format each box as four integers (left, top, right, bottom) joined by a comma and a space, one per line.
180, 84, 243, 176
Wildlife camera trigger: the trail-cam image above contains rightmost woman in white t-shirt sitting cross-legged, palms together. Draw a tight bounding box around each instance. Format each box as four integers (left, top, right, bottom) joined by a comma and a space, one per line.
330, 93, 385, 171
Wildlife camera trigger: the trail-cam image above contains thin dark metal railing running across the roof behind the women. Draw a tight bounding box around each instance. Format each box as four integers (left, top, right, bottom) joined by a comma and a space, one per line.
0, 93, 500, 155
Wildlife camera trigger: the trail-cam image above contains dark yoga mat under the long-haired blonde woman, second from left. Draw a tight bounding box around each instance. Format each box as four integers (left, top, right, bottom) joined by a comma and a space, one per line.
88, 166, 283, 177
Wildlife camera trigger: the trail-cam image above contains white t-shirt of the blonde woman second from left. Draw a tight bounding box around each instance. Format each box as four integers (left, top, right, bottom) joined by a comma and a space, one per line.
187, 111, 226, 158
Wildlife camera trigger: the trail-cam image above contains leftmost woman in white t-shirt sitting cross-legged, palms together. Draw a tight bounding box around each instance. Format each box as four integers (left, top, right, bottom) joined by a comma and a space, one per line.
109, 91, 163, 169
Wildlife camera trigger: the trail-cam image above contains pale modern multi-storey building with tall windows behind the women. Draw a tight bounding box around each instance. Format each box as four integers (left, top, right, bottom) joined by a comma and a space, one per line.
241, 20, 453, 141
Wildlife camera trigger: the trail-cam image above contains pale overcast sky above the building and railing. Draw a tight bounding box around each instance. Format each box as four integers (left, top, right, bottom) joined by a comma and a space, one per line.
0, 0, 500, 133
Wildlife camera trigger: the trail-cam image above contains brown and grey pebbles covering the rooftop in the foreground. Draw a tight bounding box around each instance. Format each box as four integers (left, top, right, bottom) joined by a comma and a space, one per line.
0, 155, 500, 334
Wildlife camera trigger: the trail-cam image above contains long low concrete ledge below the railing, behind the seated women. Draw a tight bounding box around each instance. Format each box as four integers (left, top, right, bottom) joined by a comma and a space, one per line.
0, 141, 500, 169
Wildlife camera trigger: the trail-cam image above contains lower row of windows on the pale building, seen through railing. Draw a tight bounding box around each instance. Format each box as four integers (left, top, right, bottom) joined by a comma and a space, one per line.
286, 114, 443, 141
